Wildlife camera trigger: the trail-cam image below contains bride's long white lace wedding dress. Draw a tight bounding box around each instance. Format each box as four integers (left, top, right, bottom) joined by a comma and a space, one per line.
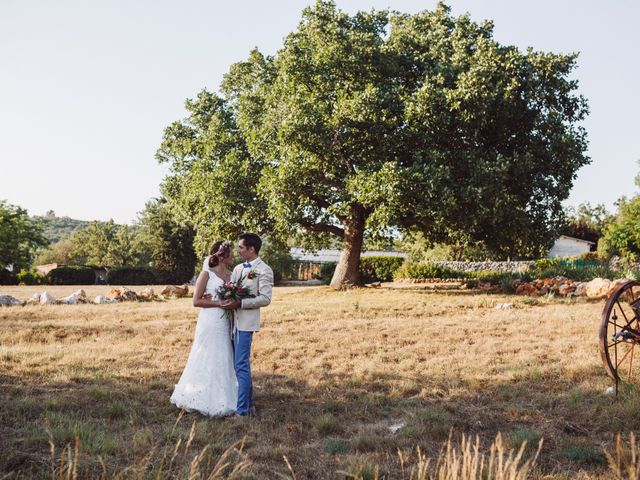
171, 270, 238, 417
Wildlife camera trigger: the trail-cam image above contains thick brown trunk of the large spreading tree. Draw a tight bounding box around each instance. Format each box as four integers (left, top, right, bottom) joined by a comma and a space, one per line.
331, 211, 365, 290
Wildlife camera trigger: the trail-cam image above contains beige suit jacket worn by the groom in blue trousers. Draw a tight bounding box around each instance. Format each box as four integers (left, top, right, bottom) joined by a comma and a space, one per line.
231, 257, 273, 332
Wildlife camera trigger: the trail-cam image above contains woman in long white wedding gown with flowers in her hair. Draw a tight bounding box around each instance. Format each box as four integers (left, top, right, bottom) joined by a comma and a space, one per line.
171, 242, 238, 417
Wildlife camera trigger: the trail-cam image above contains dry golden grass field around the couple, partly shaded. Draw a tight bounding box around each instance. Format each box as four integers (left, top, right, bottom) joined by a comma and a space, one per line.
0, 287, 640, 479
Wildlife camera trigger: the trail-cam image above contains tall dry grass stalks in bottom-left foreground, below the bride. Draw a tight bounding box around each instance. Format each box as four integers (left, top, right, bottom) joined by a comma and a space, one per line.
48, 419, 251, 480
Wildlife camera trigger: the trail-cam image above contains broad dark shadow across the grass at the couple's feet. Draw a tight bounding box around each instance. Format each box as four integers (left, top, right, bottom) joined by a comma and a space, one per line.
0, 366, 640, 478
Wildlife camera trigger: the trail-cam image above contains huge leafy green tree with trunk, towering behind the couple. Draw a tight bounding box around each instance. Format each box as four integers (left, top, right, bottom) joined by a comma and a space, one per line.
157, 1, 589, 288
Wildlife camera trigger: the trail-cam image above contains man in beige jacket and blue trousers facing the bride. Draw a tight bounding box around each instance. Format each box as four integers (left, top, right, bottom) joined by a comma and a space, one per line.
221, 233, 273, 416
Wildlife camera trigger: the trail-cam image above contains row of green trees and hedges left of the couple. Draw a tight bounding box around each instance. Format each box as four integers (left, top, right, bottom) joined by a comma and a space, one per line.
0, 199, 197, 283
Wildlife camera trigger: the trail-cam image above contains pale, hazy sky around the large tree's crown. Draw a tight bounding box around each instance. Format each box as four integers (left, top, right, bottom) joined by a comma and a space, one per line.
0, 0, 640, 223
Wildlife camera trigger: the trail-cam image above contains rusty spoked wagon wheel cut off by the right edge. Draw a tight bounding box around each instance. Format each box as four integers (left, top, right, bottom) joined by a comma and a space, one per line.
600, 280, 640, 385
